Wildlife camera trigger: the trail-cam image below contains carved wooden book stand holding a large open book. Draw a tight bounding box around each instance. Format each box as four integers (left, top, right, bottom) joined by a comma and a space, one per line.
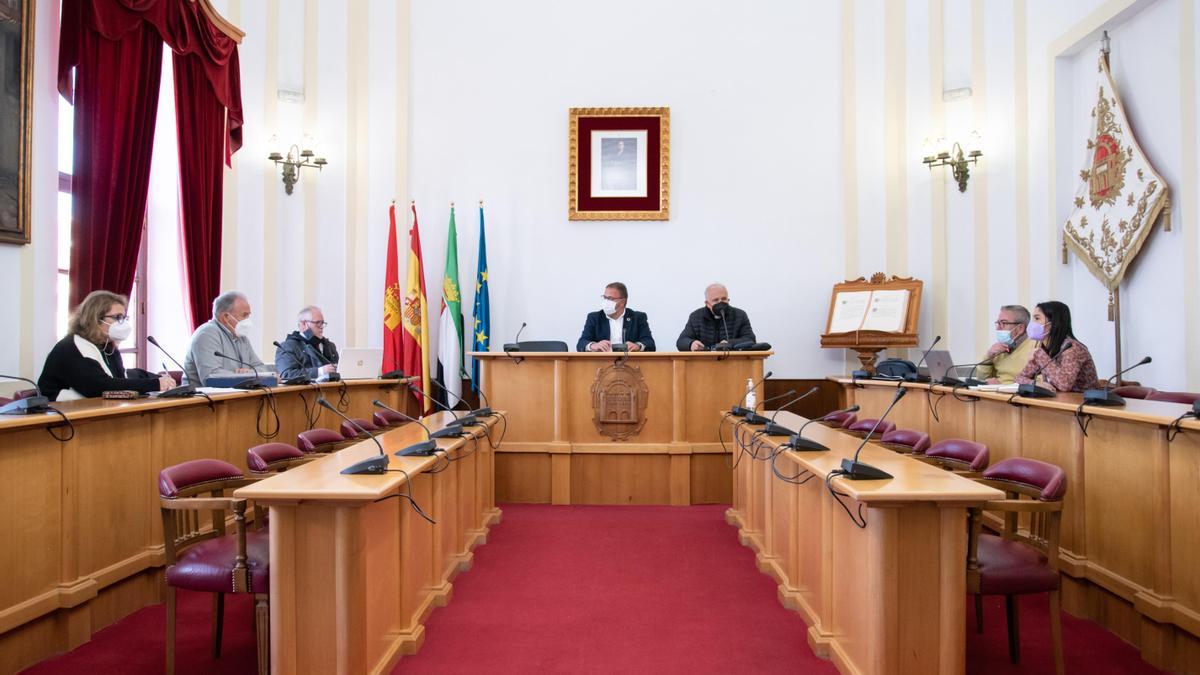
821, 273, 924, 374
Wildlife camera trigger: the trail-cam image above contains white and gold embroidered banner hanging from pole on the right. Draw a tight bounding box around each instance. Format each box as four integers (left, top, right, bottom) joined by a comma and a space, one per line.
1062, 56, 1170, 302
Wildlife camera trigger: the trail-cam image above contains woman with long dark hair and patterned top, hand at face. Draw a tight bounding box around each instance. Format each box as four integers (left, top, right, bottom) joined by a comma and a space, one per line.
1016, 300, 1096, 392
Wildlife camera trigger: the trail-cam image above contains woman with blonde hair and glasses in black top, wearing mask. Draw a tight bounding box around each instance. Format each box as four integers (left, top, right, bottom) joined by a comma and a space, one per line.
37, 291, 175, 401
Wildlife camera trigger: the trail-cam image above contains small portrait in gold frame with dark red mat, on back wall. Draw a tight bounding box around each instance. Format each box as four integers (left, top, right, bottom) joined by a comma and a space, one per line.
568, 108, 671, 220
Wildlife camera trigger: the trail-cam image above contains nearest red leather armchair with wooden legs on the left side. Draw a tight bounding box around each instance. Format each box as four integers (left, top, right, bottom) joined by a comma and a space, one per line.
158, 459, 270, 675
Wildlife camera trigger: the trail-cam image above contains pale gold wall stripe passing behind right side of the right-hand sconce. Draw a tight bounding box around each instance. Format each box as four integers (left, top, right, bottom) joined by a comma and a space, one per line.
968, 0, 994, 354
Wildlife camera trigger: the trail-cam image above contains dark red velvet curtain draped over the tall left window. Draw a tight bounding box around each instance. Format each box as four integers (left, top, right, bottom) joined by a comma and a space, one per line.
59, 0, 242, 314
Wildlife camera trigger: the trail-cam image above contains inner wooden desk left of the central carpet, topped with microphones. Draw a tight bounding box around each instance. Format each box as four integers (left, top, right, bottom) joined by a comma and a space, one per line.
235, 413, 500, 674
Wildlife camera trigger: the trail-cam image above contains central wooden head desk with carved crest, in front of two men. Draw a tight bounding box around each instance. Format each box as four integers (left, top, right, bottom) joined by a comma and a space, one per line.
472, 352, 770, 504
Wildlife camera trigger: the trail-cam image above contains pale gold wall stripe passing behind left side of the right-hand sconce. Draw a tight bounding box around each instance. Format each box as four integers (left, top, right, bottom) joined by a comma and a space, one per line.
929, 0, 950, 338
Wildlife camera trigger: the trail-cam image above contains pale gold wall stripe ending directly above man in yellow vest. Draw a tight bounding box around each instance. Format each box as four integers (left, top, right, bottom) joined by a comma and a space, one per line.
1013, 0, 1034, 306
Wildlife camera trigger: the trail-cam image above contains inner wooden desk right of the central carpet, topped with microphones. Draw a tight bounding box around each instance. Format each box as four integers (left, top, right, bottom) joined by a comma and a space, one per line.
726, 412, 1004, 675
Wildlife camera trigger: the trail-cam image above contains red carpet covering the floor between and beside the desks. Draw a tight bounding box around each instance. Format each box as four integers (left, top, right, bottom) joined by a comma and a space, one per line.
18, 504, 1156, 675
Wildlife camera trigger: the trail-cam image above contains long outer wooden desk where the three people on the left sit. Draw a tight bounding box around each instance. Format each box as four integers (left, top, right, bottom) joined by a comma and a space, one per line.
0, 380, 415, 673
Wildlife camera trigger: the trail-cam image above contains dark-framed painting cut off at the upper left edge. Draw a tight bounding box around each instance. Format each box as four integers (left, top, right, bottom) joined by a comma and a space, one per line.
0, 0, 34, 244
